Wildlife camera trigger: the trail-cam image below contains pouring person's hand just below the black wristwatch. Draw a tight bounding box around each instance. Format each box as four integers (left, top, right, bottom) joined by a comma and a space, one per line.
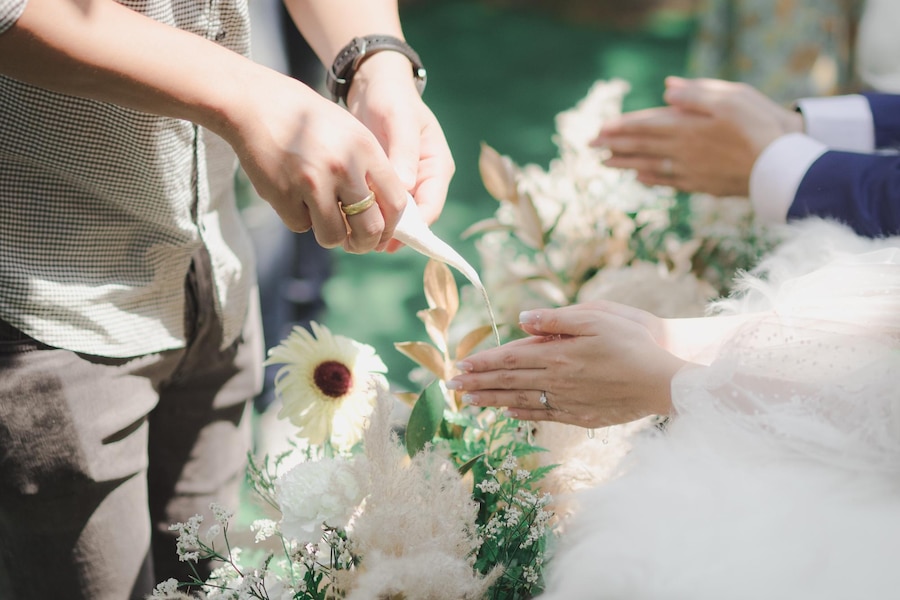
347, 52, 456, 244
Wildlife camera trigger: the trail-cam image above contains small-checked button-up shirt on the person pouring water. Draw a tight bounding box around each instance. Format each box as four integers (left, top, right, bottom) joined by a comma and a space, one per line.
0, 0, 255, 357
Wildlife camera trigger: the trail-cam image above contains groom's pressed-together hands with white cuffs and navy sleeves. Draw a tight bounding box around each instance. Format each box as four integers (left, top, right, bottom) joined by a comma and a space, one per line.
599, 78, 900, 236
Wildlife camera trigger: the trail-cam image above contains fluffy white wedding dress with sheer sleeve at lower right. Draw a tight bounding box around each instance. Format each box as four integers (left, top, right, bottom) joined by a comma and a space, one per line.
541, 221, 900, 600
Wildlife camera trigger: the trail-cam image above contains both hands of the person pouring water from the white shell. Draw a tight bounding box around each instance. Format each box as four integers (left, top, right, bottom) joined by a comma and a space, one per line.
222, 52, 454, 253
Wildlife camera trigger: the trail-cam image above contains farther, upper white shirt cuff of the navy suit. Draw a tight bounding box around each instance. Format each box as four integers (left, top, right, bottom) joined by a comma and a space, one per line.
797, 94, 875, 152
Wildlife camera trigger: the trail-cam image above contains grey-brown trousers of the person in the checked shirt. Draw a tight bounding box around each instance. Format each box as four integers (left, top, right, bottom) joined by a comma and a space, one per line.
0, 252, 263, 600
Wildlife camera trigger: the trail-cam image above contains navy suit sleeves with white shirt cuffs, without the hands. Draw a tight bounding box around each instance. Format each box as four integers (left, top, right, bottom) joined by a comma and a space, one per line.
750, 94, 900, 237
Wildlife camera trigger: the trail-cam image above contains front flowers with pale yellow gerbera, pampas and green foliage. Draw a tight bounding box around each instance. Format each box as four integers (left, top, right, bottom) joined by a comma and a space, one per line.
153, 261, 554, 600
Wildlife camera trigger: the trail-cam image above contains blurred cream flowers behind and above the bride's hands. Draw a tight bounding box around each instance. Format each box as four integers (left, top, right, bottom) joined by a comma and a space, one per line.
464, 80, 776, 330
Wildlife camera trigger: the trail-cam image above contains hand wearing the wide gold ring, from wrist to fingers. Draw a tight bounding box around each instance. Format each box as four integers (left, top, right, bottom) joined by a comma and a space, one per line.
221, 70, 406, 253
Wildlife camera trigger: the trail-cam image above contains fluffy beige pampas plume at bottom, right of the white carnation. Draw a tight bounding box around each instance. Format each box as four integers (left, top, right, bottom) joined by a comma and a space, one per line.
341, 384, 500, 600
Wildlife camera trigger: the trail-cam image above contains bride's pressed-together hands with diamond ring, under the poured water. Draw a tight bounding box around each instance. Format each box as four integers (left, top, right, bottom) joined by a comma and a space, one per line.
448, 302, 685, 428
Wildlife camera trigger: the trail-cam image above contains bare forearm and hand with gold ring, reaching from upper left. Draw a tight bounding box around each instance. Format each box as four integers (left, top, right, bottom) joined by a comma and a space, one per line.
0, 0, 406, 252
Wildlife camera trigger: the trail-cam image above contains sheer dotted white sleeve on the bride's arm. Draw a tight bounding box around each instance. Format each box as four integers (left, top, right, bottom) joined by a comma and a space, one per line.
673, 237, 900, 474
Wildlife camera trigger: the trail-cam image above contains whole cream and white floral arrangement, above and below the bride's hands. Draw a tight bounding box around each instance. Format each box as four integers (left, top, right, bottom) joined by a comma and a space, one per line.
153, 81, 777, 600
